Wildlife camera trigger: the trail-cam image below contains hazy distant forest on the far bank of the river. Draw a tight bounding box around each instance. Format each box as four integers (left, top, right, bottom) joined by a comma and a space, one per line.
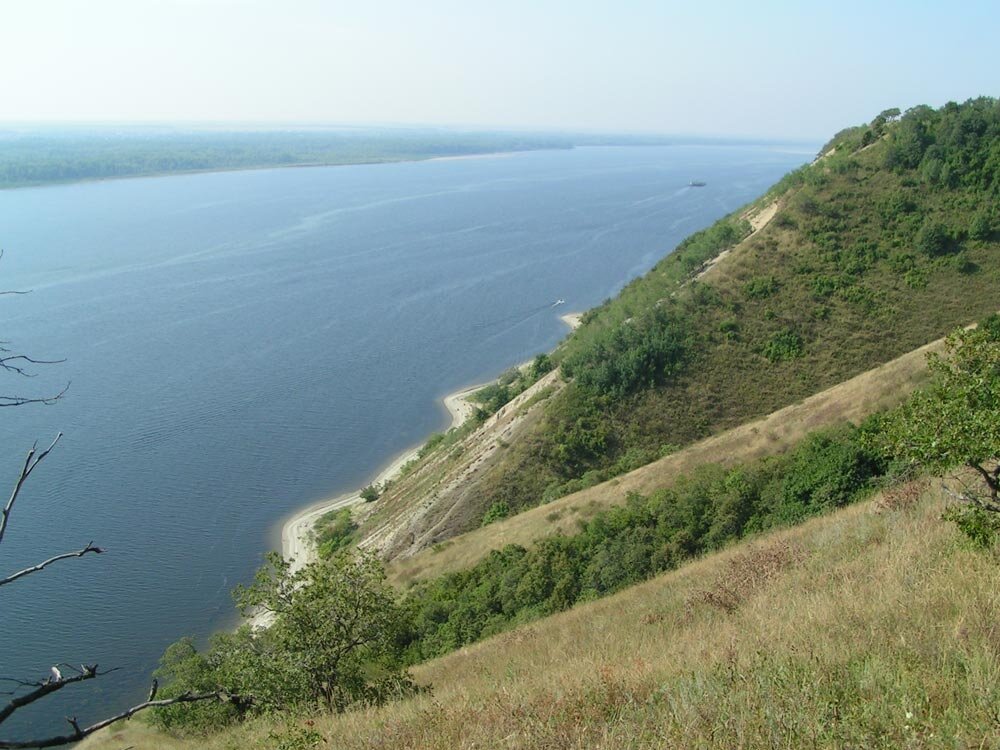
0, 126, 796, 188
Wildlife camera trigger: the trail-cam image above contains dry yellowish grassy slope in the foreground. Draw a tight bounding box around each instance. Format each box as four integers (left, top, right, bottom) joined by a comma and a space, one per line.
87, 490, 1000, 750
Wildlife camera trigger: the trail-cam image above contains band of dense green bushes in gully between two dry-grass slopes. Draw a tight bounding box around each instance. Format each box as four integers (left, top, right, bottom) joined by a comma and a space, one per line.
408, 427, 886, 661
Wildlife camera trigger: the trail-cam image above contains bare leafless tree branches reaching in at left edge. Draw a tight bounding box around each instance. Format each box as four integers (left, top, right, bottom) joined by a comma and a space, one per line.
0, 262, 245, 750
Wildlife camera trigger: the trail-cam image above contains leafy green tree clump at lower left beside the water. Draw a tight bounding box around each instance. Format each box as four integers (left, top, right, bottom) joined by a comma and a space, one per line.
155, 553, 413, 731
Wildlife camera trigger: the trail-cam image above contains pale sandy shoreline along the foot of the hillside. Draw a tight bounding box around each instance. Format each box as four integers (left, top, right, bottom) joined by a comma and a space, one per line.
280, 313, 583, 572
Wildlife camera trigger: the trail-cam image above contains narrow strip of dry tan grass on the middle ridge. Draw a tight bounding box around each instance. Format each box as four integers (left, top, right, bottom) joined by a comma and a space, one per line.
389, 340, 943, 584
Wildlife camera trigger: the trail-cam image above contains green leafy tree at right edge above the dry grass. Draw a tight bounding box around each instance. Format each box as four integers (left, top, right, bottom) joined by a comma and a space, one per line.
883, 326, 1000, 513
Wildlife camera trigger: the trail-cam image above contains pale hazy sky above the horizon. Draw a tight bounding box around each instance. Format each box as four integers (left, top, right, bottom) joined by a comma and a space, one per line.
0, 0, 1000, 138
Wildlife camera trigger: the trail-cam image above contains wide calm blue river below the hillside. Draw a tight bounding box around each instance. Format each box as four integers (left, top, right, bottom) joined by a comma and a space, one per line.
0, 147, 809, 730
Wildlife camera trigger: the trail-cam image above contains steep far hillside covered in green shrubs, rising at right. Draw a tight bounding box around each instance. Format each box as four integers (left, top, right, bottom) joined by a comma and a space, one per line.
458, 98, 1000, 524
